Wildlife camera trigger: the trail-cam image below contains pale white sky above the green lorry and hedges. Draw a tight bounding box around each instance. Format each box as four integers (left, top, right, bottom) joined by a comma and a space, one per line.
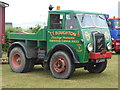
1, 0, 119, 28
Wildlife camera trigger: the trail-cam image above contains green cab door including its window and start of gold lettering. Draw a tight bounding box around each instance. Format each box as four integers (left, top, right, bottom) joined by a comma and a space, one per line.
47, 13, 65, 52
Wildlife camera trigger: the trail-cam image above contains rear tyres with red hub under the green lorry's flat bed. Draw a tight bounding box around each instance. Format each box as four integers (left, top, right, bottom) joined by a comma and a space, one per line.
9, 47, 34, 73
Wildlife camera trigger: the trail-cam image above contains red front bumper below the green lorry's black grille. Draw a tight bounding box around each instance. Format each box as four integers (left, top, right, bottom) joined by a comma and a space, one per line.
89, 51, 112, 59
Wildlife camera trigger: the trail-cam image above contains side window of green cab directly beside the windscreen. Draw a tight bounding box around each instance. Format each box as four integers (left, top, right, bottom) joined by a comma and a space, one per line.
65, 14, 78, 29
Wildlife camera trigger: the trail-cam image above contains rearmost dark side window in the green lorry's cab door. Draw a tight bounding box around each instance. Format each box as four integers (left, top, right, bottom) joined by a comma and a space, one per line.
50, 14, 63, 29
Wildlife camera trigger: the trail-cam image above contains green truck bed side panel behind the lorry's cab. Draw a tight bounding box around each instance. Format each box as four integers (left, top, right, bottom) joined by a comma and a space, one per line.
8, 29, 46, 41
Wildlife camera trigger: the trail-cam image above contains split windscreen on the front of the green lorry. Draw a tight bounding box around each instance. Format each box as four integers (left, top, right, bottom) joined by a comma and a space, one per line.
77, 14, 108, 28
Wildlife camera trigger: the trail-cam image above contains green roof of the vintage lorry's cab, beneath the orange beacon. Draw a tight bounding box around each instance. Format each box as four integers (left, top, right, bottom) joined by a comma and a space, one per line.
49, 10, 103, 15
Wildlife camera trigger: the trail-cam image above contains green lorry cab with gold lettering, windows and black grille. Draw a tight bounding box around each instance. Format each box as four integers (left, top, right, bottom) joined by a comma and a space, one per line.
47, 10, 111, 63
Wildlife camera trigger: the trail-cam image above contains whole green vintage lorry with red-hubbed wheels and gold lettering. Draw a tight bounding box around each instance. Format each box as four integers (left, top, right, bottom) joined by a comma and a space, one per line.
8, 7, 112, 79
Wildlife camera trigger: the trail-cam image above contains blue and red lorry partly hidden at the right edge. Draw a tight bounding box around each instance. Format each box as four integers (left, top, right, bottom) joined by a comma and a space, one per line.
107, 17, 120, 54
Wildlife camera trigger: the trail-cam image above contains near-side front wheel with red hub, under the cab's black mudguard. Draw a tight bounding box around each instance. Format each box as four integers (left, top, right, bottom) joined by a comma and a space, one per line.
50, 51, 75, 79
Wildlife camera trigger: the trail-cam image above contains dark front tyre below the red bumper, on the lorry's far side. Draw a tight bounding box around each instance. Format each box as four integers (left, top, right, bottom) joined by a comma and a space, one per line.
87, 60, 107, 73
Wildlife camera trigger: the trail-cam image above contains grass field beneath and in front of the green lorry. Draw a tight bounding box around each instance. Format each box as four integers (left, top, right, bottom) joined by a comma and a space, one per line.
2, 55, 118, 88
